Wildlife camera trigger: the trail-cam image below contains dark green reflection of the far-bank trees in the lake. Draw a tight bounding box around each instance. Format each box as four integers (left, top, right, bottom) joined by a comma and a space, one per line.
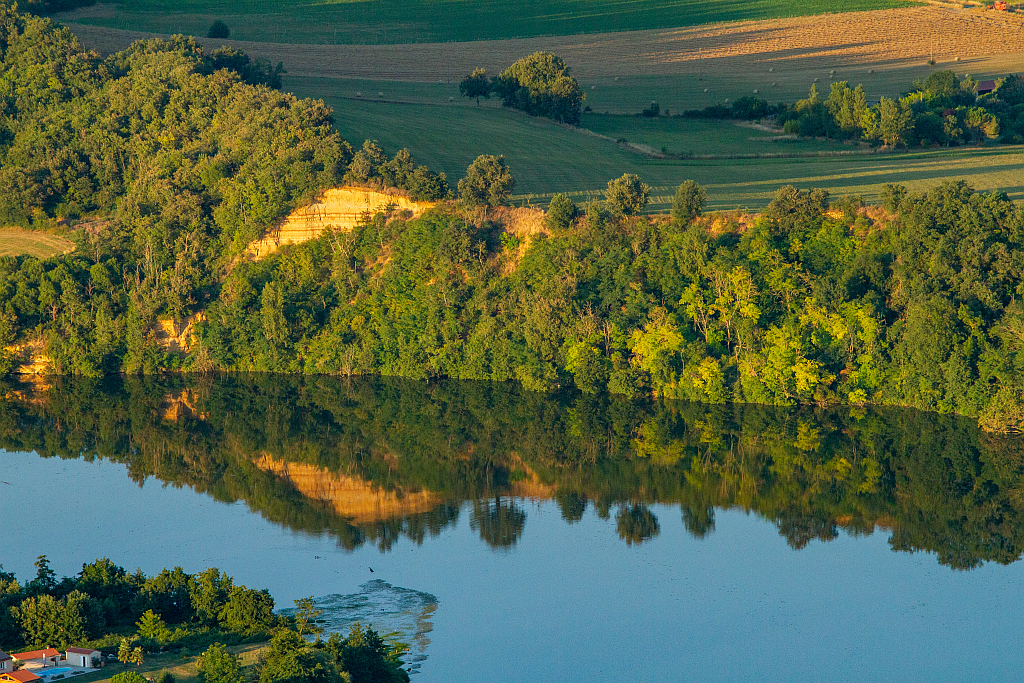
0, 376, 1024, 567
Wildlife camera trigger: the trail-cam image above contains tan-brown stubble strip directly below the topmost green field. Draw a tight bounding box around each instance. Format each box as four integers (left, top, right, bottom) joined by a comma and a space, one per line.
69, 6, 1024, 82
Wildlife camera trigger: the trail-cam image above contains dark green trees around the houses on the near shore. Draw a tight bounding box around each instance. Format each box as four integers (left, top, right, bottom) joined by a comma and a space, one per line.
0, 555, 409, 683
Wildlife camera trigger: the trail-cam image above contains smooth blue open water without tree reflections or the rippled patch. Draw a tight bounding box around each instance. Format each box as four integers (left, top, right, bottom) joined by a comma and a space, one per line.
0, 451, 1024, 683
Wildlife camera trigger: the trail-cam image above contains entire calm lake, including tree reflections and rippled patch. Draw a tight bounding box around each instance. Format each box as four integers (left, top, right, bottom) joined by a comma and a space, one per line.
0, 377, 1024, 682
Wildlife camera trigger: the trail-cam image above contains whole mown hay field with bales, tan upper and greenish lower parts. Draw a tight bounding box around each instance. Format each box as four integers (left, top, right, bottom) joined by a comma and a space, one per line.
71, 6, 1024, 114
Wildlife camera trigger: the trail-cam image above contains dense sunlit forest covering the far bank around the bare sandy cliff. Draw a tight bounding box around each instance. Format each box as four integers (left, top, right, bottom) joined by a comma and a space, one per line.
0, 9, 1024, 430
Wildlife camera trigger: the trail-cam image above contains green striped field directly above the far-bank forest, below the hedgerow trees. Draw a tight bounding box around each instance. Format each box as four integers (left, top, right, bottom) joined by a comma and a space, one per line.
286, 79, 1024, 210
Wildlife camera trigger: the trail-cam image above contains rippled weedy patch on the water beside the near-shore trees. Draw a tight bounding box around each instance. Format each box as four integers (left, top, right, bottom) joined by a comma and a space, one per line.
281, 579, 437, 673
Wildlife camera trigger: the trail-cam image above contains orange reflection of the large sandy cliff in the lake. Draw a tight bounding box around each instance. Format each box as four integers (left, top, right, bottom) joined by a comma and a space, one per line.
255, 455, 443, 523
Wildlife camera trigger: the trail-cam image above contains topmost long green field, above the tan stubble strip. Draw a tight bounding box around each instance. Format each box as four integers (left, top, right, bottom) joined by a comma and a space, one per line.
61, 0, 913, 44
